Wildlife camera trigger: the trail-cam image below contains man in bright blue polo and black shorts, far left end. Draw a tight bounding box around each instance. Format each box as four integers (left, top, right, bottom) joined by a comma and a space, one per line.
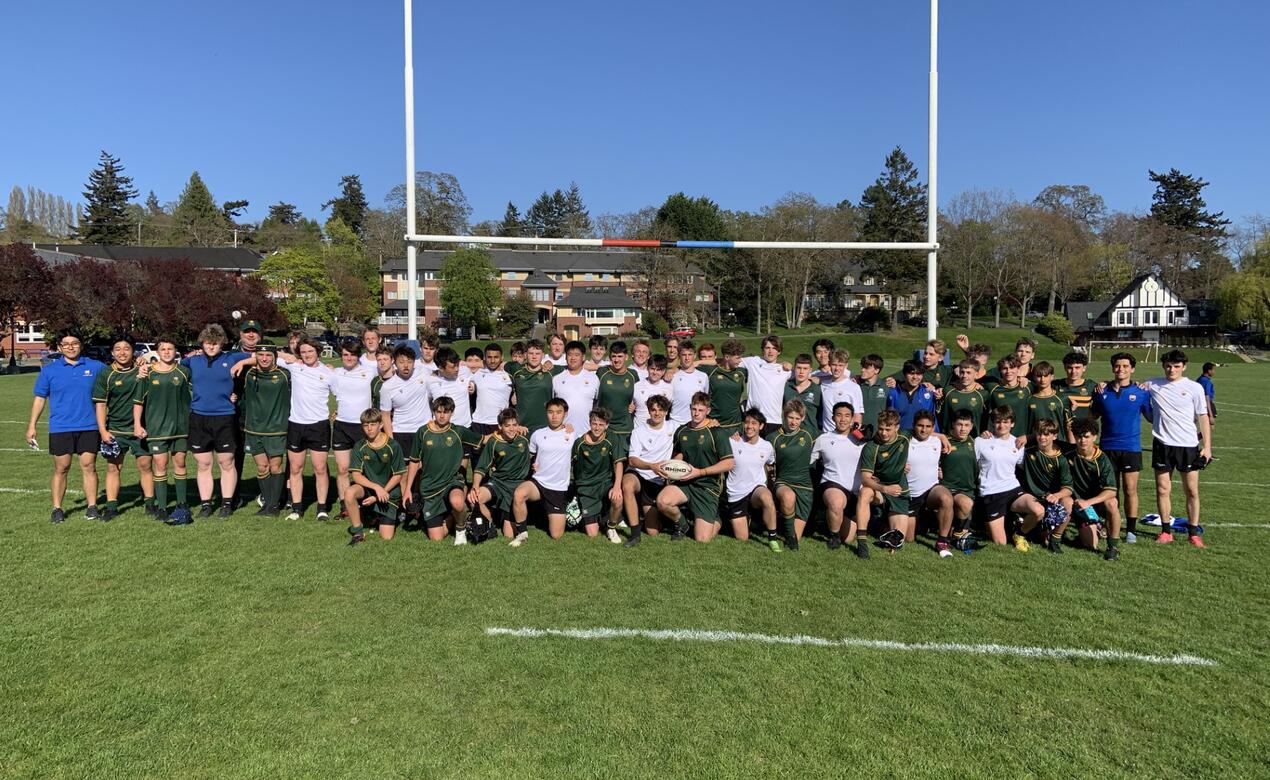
27, 330, 105, 523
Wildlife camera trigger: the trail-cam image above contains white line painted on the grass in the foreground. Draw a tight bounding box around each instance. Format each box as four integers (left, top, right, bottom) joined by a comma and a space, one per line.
485, 628, 1218, 666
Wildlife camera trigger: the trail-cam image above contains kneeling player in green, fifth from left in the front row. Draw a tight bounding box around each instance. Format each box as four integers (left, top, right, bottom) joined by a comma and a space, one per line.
572, 409, 626, 544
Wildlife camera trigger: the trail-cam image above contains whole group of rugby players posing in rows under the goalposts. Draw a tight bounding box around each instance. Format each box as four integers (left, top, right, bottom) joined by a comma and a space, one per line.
28, 323, 1213, 560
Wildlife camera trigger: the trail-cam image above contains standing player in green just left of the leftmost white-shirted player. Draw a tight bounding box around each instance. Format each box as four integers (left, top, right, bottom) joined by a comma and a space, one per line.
240, 344, 289, 517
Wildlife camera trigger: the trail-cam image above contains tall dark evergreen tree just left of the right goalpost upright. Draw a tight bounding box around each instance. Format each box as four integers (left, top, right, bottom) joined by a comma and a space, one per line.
860, 146, 926, 330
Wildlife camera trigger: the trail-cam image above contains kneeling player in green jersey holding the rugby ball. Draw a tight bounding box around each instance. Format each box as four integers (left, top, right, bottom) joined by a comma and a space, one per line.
657, 393, 733, 541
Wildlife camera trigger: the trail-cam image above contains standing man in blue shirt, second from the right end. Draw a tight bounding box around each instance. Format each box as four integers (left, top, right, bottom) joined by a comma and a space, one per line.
1092, 352, 1151, 544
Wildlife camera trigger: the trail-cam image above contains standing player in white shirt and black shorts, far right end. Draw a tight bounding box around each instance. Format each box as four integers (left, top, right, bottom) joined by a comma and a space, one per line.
1142, 349, 1213, 548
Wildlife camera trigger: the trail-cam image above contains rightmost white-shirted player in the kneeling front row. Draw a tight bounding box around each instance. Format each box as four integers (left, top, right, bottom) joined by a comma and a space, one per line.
974, 407, 1045, 553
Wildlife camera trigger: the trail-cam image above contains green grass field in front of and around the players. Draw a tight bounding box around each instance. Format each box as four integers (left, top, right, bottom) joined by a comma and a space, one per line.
0, 337, 1270, 777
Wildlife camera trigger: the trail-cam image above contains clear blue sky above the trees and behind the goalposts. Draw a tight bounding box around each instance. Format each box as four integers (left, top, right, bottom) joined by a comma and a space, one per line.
0, 0, 1270, 232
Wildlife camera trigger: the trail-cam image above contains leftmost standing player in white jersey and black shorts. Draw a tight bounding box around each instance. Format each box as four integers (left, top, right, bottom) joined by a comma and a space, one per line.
278, 337, 337, 520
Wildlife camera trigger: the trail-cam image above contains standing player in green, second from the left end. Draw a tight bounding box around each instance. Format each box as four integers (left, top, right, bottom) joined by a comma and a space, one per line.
93, 338, 155, 521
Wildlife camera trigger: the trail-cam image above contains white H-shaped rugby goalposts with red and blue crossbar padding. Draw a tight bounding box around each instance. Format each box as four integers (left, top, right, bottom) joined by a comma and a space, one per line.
404, 0, 940, 339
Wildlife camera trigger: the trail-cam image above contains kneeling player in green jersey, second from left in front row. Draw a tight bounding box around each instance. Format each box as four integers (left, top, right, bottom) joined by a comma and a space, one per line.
401, 395, 480, 545
